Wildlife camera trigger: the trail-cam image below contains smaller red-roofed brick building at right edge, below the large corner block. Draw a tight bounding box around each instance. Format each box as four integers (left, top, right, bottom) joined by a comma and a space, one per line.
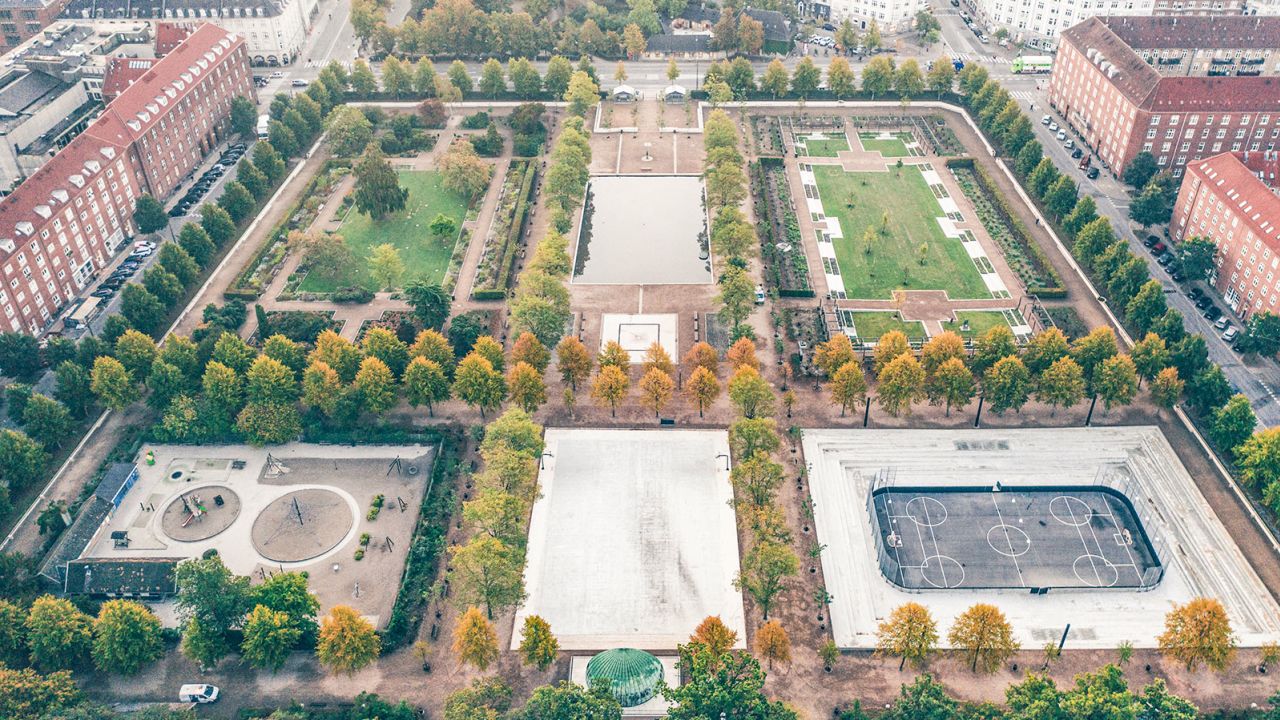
1170, 152, 1280, 318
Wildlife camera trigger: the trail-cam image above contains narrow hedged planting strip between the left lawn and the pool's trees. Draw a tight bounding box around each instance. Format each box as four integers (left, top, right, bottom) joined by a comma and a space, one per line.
471, 160, 538, 300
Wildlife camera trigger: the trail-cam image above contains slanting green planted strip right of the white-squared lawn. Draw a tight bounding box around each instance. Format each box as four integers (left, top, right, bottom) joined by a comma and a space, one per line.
947, 158, 1066, 299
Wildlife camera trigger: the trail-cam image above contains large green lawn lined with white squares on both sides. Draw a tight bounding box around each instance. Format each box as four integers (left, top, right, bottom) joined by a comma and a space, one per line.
813, 165, 991, 300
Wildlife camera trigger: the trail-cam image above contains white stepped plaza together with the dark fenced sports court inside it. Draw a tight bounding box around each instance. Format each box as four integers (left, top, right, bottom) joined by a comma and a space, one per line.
804, 427, 1280, 648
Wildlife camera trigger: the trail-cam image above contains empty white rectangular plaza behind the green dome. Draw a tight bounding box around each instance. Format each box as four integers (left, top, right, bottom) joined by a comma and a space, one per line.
512, 428, 746, 651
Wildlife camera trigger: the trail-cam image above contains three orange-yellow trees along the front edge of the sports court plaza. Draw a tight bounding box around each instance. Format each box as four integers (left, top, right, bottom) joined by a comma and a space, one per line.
876, 597, 1233, 673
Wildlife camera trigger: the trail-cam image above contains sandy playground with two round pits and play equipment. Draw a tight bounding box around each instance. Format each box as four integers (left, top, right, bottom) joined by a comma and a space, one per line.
84, 443, 434, 625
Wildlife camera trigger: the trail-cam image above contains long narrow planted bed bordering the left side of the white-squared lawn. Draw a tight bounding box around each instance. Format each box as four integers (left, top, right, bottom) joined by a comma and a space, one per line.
751, 158, 814, 297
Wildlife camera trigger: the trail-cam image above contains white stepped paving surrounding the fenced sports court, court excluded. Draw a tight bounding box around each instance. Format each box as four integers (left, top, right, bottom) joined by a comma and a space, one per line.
804, 427, 1280, 648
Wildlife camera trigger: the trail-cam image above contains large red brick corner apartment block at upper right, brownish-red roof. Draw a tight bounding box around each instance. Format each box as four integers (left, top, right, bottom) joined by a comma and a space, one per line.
1050, 17, 1280, 176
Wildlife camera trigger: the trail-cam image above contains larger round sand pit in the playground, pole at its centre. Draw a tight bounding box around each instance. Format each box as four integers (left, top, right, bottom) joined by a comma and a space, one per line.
252, 488, 356, 562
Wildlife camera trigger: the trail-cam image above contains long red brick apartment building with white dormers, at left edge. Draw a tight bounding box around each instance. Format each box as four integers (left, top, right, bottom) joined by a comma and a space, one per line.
0, 24, 253, 334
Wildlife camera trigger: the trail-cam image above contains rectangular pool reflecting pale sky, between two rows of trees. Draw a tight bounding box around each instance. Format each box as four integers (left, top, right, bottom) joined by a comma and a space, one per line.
573, 176, 712, 284
